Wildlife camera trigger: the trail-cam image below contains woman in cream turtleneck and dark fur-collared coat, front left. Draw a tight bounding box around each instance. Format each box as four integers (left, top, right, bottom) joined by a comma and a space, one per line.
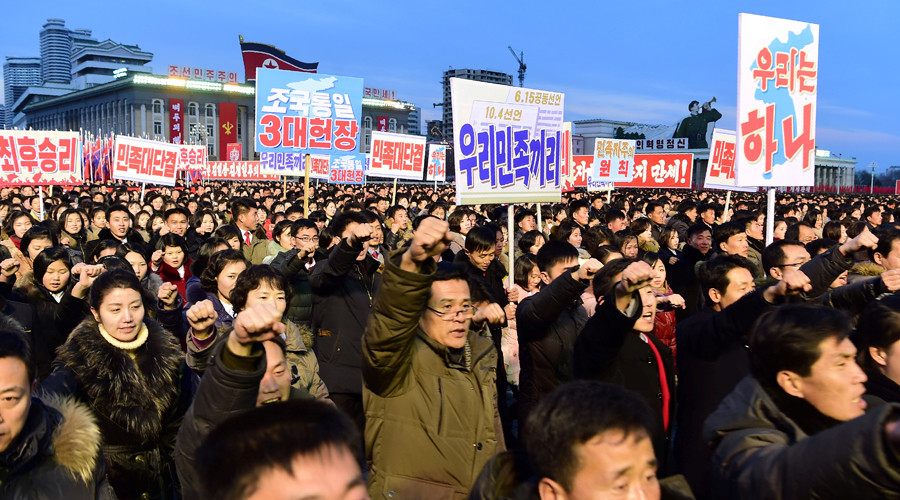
41, 270, 189, 499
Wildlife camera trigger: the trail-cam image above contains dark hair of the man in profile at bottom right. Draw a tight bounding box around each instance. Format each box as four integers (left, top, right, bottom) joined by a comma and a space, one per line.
750, 304, 850, 387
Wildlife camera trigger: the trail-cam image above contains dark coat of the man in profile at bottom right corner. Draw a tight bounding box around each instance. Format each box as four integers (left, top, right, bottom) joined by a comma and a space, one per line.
704, 376, 900, 500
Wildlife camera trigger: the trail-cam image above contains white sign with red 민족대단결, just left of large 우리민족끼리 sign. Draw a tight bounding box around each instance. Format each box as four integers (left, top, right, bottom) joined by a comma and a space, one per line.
366, 131, 425, 181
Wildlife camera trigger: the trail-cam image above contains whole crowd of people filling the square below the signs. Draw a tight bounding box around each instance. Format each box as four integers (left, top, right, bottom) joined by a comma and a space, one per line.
0, 182, 900, 500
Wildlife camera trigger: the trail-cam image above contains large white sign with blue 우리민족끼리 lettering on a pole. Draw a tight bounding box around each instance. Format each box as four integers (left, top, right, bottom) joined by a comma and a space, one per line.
450, 78, 565, 205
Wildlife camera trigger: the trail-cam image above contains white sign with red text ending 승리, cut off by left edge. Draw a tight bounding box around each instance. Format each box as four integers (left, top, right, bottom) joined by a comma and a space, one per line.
0, 130, 84, 186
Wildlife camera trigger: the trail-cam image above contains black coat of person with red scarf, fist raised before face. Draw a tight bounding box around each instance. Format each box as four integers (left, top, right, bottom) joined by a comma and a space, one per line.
576, 291, 680, 475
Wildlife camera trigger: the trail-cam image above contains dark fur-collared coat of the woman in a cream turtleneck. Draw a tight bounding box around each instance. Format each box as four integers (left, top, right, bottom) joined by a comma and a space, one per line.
41, 317, 190, 499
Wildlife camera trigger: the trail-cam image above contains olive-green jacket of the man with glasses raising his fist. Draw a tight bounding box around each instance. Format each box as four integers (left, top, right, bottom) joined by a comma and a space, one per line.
363, 252, 505, 499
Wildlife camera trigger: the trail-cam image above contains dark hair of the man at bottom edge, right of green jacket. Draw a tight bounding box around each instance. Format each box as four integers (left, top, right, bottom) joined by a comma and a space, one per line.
523, 380, 655, 491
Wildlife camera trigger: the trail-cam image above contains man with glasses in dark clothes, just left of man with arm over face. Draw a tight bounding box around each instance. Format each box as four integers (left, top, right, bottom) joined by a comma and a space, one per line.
272, 219, 319, 348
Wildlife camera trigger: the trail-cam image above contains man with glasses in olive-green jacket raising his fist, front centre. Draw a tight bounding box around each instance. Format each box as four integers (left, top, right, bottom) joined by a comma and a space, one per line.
362, 217, 504, 499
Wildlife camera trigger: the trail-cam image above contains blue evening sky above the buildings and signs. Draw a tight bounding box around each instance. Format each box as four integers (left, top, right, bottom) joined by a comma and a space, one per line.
0, 0, 900, 170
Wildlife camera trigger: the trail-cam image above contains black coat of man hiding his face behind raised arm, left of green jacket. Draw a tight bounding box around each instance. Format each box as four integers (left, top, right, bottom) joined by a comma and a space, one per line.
309, 239, 382, 395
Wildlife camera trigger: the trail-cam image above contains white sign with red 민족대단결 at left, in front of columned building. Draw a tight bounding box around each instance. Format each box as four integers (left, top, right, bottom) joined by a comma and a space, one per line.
112, 135, 181, 186
